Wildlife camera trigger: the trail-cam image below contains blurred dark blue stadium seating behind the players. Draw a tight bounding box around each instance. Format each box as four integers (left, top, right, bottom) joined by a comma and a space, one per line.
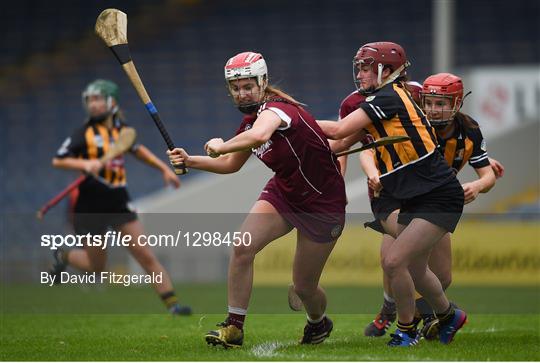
0, 0, 540, 216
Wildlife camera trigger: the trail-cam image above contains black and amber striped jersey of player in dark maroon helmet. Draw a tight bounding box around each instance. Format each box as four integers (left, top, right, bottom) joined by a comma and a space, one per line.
359, 81, 454, 199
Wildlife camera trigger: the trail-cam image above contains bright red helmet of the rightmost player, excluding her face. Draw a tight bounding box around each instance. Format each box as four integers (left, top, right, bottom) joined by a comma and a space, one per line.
421, 73, 463, 126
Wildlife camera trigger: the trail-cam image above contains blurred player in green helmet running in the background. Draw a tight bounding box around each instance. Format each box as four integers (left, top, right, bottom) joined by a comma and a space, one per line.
51, 79, 191, 315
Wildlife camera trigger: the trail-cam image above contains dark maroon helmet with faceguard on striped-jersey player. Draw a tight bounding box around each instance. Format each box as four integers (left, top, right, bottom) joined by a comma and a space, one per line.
353, 42, 410, 95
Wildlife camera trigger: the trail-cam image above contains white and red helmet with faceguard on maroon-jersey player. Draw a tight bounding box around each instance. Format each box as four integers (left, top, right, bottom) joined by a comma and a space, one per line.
225, 52, 268, 114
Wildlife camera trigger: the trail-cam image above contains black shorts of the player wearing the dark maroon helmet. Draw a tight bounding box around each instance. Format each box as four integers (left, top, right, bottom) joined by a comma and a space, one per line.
398, 178, 465, 232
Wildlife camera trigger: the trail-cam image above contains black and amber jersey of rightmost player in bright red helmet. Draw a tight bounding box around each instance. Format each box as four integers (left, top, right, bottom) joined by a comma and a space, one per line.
437, 114, 490, 173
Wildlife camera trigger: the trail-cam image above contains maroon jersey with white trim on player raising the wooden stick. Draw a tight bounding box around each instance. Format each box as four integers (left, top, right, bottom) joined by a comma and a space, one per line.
236, 100, 343, 203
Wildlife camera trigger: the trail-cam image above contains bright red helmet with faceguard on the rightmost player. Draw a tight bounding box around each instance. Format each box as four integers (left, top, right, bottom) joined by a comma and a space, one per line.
420, 73, 463, 127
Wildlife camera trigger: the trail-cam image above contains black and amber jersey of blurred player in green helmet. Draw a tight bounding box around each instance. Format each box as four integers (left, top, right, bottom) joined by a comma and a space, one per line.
56, 118, 137, 188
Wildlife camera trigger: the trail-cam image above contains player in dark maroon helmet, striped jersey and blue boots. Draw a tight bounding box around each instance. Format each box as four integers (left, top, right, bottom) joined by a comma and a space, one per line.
318, 42, 466, 346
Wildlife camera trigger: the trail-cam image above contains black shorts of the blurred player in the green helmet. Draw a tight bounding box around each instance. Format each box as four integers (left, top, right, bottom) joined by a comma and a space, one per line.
73, 181, 137, 235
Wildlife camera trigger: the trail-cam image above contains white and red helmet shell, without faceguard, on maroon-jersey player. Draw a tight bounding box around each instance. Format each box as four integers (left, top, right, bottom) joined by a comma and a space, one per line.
225, 52, 268, 89
